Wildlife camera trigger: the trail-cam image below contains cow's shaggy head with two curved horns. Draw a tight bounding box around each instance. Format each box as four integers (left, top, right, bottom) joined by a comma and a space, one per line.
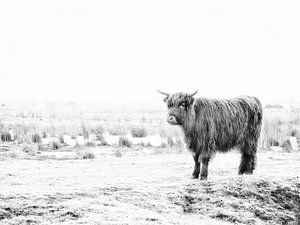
158, 90, 198, 125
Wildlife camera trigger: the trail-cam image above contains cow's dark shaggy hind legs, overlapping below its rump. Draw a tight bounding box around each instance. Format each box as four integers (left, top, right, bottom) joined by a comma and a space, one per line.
238, 140, 257, 175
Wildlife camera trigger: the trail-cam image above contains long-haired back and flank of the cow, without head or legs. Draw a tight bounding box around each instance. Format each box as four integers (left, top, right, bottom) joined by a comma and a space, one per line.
195, 96, 262, 151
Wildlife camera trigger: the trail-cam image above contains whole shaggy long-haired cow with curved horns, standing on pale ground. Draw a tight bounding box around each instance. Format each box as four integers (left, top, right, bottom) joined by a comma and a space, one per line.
159, 91, 262, 180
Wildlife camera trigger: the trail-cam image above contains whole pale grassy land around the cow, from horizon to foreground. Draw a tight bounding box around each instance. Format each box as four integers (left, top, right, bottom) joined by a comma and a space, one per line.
0, 103, 300, 225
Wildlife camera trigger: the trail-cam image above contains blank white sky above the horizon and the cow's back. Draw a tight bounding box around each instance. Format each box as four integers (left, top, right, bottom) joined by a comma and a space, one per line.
0, 0, 300, 103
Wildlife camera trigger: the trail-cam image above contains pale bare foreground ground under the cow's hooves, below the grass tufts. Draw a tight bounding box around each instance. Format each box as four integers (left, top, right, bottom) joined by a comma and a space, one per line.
0, 149, 300, 224
